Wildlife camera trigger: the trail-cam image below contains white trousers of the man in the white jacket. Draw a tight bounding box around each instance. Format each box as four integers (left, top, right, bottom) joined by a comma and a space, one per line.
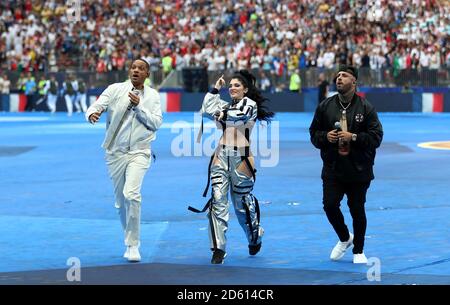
106, 152, 151, 246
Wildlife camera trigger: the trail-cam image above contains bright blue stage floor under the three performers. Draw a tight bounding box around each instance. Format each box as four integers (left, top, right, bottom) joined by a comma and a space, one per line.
0, 113, 450, 284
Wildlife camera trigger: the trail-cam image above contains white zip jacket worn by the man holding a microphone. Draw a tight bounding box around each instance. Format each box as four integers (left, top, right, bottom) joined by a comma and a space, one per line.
86, 80, 162, 153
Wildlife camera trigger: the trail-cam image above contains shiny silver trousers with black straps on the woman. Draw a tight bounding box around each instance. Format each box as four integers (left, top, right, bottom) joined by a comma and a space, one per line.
207, 146, 264, 251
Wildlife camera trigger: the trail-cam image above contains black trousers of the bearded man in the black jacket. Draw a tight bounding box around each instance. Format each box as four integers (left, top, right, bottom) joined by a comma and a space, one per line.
323, 179, 370, 253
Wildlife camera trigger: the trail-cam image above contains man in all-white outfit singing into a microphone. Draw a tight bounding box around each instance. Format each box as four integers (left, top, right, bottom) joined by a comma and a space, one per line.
86, 59, 162, 262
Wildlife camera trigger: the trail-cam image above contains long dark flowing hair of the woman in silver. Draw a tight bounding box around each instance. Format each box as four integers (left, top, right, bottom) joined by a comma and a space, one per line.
231, 70, 275, 123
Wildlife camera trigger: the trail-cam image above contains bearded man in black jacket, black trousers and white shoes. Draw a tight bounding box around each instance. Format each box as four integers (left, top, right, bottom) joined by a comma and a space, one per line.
309, 65, 383, 264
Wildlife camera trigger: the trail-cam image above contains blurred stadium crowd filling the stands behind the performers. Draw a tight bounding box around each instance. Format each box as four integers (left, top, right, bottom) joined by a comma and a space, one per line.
0, 0, 450, 83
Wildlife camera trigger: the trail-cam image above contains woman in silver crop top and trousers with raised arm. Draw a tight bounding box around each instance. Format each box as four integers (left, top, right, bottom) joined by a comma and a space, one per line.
189, 70, 274, 264
